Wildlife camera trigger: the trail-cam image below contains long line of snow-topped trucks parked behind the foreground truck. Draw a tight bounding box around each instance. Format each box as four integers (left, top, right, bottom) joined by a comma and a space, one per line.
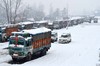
0, 17, 98, 42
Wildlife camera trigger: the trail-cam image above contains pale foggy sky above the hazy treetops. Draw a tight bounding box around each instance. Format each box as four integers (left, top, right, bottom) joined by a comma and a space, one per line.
24, 0, 100, 15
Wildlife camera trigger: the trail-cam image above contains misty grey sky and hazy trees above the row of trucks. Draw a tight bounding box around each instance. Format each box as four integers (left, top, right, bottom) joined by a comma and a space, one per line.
0, 0, 100, 24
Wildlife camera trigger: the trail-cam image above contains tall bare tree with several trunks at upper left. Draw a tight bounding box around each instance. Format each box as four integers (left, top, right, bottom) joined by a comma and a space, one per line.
0, 0, 22, 23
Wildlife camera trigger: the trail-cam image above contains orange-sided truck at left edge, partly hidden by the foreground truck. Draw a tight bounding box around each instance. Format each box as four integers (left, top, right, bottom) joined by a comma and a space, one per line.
0, 24, 18, 42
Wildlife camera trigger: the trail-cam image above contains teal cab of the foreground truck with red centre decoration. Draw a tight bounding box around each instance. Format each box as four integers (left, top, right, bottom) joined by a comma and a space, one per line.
9, 32, 32, 60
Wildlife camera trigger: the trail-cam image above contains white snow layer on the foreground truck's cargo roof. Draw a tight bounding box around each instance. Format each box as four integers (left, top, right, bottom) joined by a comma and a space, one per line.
23, 27, 51, 34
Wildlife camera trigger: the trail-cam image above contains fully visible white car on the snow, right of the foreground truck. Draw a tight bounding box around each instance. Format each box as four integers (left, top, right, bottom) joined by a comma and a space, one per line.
59, 33, 71, 43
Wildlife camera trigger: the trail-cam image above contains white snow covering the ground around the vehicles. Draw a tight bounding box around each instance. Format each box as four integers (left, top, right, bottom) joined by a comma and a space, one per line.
0, 23, 100, 66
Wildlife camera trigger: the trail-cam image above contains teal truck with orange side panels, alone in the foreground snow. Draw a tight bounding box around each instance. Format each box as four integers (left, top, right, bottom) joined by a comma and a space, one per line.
9, 27, 51, 61
